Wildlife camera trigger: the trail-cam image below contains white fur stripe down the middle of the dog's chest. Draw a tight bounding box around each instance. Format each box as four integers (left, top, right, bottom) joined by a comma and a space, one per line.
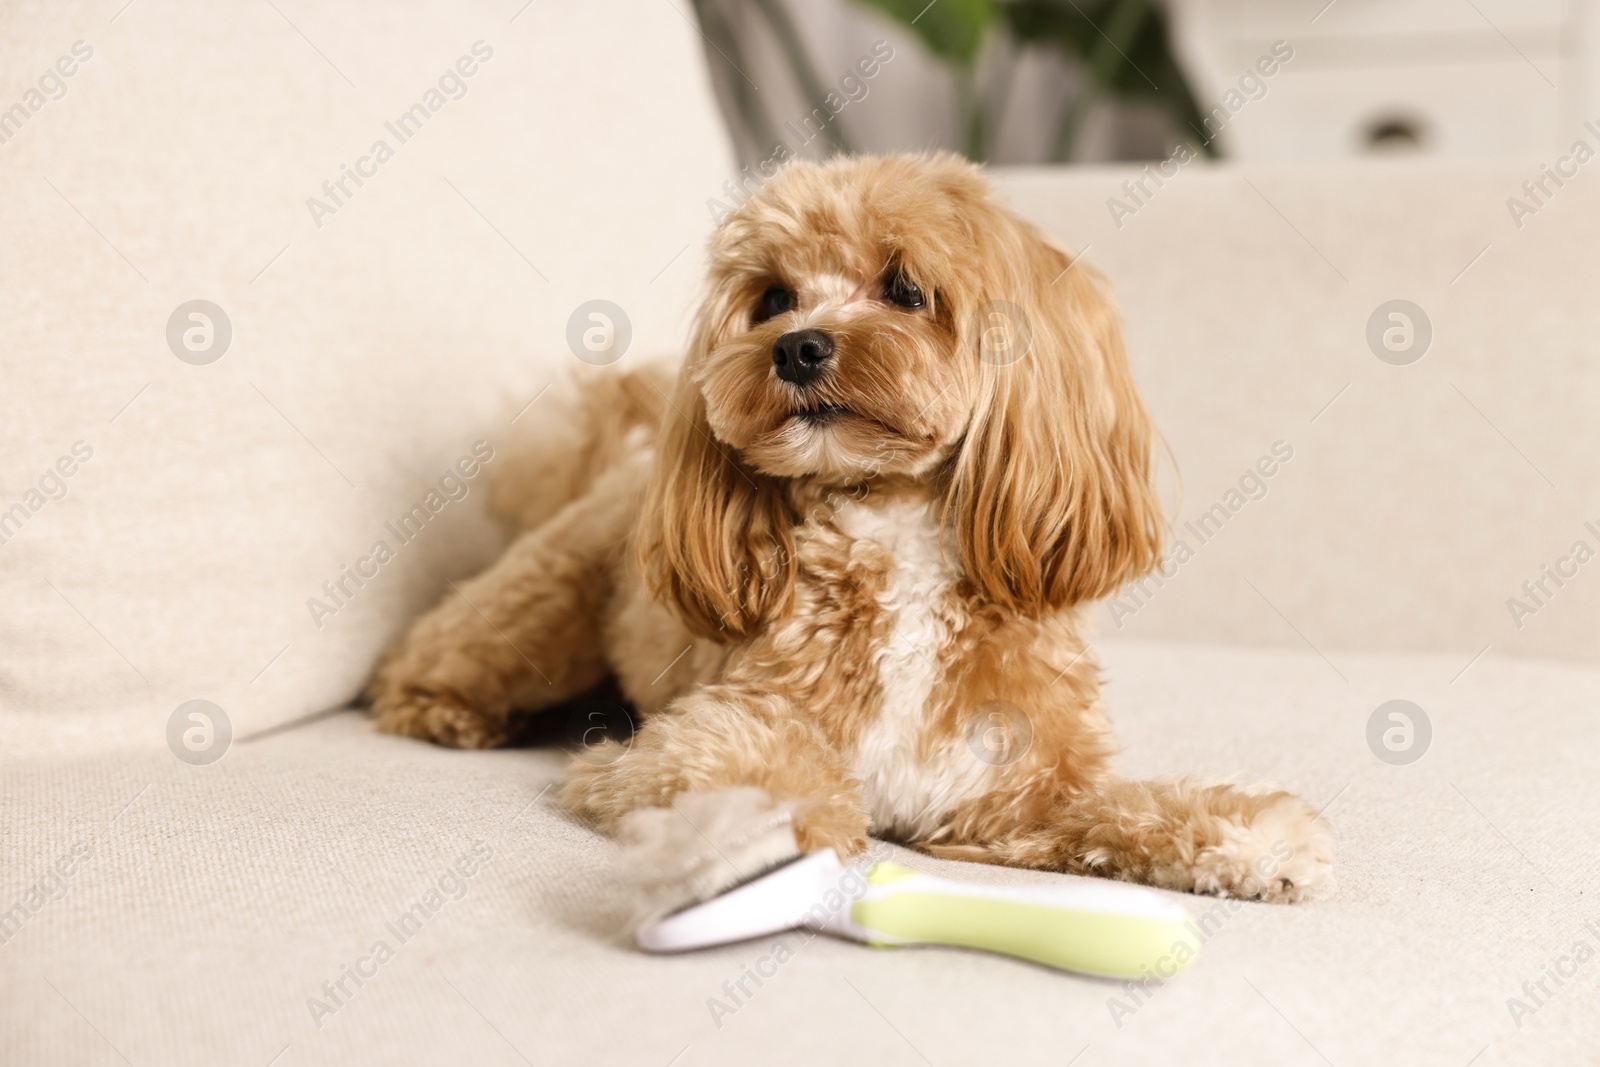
834, 501, 994, 837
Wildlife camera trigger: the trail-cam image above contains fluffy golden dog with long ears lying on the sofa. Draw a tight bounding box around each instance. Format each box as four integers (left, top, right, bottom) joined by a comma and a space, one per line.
370, 155, 1331, 901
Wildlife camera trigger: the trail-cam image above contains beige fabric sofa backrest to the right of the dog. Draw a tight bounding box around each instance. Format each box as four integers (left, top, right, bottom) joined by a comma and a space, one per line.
1003, 162, 1600, 664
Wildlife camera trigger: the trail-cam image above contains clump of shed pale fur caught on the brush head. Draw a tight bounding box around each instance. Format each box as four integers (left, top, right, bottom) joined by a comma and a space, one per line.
618, 785, 800, 925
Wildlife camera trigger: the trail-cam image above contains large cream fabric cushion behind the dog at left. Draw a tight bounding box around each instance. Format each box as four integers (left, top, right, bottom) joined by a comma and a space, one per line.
0, 0, 731, 752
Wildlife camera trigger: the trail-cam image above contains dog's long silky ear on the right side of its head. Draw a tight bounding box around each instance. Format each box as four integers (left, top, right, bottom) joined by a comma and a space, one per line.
947, 210, 1163, 614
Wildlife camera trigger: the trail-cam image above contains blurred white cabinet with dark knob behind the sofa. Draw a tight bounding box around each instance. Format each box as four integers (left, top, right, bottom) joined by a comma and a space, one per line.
1168, 0, 1600, 160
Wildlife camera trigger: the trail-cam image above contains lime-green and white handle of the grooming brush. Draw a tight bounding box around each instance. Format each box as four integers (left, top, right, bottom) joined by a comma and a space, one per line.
829, 862, 1200, 977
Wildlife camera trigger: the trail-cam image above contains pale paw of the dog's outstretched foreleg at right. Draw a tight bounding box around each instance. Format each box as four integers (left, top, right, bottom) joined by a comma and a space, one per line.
1186, 793, 1333, 904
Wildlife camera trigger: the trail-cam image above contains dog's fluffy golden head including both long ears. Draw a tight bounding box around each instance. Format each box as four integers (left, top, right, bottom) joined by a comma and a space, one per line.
638, 155, 1160, 638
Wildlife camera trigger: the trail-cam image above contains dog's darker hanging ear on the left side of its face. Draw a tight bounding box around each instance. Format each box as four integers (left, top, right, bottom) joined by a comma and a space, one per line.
635, 334, 795, 641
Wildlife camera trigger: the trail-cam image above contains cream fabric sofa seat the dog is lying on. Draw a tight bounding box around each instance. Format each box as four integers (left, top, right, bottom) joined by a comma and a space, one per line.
0, 643, 1600, 1067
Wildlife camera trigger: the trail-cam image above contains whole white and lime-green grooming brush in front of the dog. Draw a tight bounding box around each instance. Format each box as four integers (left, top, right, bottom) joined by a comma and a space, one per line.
638, 849, 1200, 977
